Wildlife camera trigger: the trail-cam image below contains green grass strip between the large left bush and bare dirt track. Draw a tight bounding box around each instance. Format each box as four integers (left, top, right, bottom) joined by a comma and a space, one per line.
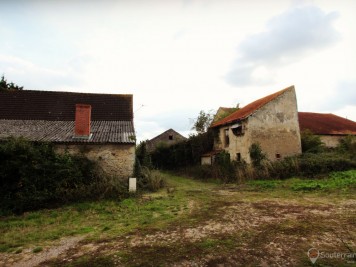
0, 174, 215, 252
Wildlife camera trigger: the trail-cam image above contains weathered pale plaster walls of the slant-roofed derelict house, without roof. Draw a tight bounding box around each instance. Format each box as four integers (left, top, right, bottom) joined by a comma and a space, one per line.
215, 88, 301, 163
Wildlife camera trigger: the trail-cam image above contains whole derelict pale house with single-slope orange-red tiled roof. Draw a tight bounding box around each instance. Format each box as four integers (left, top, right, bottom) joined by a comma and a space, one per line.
209, 86, 301, 164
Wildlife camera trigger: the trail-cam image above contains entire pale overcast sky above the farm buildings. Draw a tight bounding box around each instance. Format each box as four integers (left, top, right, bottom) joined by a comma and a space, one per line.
0, 0, 356, 140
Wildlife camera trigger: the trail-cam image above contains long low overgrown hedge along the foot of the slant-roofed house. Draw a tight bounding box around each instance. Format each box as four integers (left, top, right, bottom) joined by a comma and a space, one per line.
181, 152, 356, 183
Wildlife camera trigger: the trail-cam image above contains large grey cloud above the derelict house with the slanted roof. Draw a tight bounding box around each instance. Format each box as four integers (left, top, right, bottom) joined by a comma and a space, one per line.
226, 6, 340, 86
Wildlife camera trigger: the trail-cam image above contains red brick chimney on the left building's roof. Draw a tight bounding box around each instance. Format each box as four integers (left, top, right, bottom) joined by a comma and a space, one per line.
75, 104, 91, 138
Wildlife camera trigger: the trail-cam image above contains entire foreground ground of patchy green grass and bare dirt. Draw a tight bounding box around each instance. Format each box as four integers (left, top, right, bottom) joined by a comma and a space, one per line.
0, 171, 356, 266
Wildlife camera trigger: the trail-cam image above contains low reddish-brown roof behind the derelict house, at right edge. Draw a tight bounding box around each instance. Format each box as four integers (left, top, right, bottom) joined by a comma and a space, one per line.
298, 112, 356, 135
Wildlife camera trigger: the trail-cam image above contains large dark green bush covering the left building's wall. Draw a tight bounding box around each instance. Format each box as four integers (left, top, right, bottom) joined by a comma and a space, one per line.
0, 138, 128, 213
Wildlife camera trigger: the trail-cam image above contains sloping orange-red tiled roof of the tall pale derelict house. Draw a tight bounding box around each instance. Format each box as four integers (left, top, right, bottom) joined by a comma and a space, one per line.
211, 86, 294, 127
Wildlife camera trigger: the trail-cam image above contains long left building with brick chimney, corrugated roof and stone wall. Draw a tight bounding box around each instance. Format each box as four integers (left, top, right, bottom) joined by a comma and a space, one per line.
0, 90, 135, 179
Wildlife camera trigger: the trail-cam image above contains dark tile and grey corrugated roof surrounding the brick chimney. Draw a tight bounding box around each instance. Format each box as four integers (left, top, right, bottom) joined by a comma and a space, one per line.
0, 90, 135, 144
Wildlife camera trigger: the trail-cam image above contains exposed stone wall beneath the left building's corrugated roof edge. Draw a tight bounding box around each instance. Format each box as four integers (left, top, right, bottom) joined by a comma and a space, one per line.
55, 144, 135, 179
